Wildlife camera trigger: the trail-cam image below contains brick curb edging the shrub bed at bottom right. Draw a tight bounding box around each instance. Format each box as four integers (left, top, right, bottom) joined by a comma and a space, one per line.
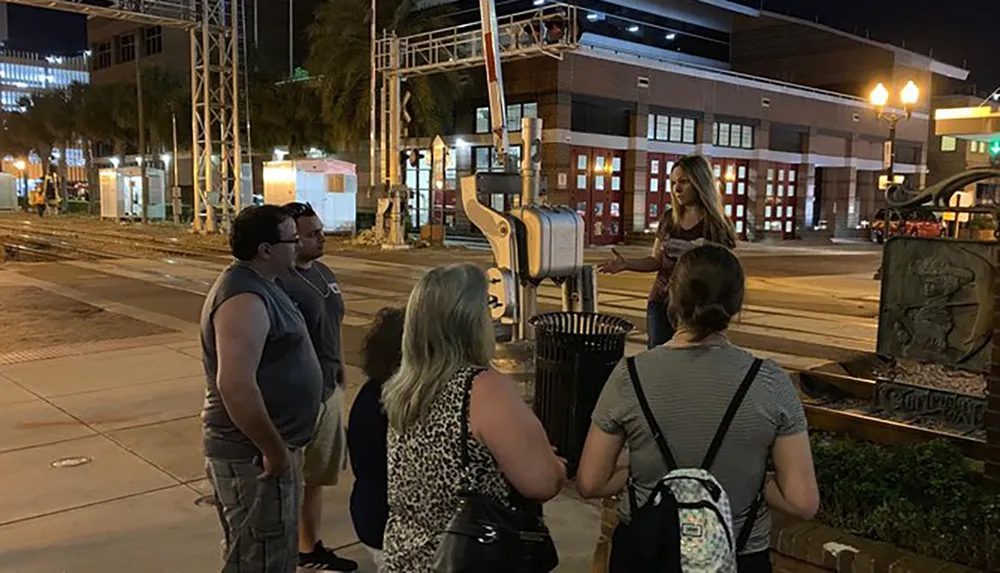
771, 510, 980, 573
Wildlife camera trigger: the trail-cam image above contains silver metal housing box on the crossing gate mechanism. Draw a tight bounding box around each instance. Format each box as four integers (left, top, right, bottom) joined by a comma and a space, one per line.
515, 205, 584, 279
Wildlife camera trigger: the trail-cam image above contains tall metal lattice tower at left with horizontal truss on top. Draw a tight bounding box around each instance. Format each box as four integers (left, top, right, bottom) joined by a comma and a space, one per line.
7, 0, 252, 232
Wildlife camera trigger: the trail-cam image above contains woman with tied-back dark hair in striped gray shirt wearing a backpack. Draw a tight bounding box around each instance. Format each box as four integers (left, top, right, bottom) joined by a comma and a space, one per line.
576, 245, 819, 573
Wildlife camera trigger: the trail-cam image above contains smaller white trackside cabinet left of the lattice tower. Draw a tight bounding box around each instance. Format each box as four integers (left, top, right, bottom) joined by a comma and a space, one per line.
100, 167, 167, 220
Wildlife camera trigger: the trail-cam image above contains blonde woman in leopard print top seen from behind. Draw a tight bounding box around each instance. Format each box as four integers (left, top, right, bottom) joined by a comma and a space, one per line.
382, 264, 566, 573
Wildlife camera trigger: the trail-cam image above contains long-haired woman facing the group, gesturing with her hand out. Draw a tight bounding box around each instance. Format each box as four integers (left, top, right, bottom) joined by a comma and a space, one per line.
599, 155, 736, 348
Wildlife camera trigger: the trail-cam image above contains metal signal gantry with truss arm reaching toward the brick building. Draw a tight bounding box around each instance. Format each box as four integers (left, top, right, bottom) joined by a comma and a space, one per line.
370, 3, 579, 189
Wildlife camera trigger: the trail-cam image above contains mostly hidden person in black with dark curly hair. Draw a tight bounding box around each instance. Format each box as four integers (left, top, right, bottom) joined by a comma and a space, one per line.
347, 308, 405, 573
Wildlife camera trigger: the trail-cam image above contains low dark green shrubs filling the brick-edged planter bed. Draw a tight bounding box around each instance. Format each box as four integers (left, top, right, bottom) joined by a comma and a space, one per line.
813, 436, 1000, 569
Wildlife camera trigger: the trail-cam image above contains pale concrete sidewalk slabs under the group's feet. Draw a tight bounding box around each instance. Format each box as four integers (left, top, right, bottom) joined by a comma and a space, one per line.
0, 333, 600, 573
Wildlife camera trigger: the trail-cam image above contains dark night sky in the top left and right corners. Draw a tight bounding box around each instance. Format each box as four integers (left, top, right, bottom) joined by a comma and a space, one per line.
8, 0, 1000, 92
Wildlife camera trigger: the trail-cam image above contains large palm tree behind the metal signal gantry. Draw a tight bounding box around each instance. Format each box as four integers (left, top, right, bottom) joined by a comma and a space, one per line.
308, 0, 461, 149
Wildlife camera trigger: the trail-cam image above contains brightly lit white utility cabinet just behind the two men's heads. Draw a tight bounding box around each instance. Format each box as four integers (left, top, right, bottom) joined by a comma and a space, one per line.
264, 159, 358, 233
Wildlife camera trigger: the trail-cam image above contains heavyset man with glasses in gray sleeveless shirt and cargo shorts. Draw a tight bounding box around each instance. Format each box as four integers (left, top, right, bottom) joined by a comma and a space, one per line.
201, 205, 323, 573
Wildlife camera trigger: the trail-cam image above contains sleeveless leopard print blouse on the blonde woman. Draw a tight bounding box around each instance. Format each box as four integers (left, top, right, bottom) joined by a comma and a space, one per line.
383, 366, 511, 573
